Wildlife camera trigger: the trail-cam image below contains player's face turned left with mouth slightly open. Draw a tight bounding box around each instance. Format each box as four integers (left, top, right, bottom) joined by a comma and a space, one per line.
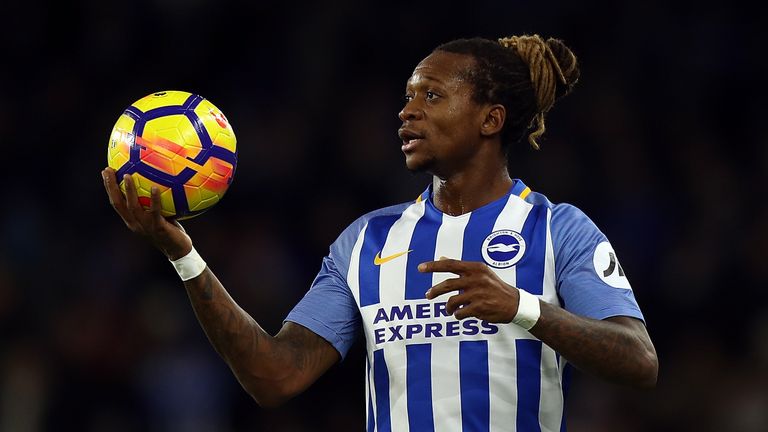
398, 51, 484, 177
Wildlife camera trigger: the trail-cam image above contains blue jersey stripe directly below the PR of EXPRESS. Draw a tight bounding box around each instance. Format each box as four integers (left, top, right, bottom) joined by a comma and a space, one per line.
405, 344, 435, 431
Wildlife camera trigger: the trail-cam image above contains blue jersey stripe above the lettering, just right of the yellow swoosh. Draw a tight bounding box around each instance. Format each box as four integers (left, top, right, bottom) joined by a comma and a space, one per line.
405, 203, 443, 300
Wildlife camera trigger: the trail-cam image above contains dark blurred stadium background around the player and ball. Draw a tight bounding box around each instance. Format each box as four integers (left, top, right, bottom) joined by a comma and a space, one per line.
0, 0, 768, 432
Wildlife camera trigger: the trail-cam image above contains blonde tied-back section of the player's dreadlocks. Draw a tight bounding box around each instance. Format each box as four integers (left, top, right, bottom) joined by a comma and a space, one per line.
499, 34, 577, 150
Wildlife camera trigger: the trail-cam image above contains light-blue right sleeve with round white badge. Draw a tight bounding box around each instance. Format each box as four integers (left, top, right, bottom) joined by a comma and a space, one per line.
551, 204, 644, 321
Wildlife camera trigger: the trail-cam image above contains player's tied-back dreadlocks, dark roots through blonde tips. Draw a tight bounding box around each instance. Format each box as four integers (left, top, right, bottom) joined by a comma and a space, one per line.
435, 35, 579, 151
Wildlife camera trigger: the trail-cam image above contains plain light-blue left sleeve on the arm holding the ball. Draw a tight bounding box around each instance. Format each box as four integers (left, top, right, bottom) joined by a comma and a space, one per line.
285, 214, 363, 359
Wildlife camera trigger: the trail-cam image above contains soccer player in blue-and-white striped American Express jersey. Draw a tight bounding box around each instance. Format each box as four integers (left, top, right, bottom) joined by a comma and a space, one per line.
102, 35, 658, 431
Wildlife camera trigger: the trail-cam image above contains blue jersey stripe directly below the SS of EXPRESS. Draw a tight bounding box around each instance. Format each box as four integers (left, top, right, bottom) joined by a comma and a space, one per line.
459, 341, 488, 432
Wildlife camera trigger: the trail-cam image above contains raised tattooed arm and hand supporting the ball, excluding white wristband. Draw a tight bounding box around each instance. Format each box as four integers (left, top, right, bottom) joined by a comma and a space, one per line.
102, 168, 341, 406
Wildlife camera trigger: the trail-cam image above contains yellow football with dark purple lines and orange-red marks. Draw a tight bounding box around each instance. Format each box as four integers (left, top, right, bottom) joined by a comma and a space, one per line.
107, 91, 237, 220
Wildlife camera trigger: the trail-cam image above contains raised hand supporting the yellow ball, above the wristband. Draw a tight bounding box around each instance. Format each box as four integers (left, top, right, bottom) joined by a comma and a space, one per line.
101, 168, 192, 260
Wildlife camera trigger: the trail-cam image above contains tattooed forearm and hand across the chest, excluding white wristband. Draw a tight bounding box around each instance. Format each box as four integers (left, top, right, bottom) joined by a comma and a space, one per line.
419, 259, 659, 388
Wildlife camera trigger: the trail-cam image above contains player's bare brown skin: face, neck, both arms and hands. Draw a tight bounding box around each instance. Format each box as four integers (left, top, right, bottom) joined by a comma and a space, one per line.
102, 52, 658, 406
